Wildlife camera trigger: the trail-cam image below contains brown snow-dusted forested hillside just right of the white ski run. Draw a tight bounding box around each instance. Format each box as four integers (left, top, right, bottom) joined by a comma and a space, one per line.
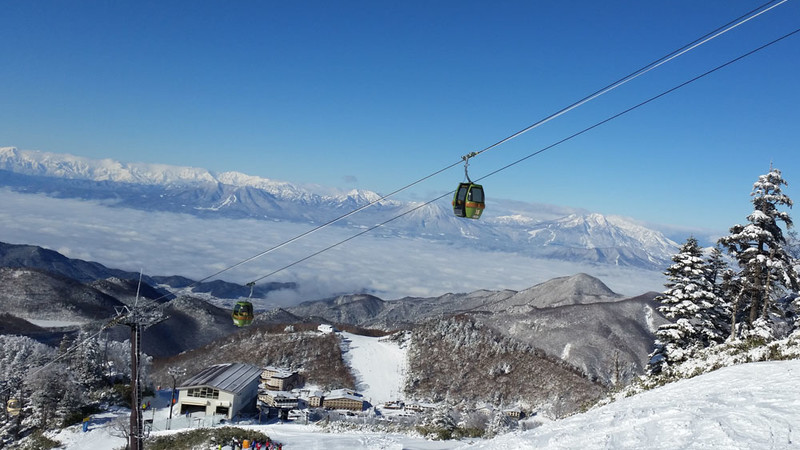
406, 316, 606, 418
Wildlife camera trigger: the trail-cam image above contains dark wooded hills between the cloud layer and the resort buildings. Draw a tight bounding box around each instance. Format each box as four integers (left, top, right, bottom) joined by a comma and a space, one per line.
0, 244, 664, 418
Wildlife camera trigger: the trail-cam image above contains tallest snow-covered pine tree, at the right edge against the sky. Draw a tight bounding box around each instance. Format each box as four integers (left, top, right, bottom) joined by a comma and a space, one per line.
719, 168, 798, 340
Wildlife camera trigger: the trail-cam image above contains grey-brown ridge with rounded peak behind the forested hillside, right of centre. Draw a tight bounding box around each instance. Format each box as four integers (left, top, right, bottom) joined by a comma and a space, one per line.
278, 273, 667, 385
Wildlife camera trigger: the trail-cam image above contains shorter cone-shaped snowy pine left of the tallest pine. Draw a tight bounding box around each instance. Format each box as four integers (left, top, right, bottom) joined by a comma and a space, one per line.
648, 237, 723, 374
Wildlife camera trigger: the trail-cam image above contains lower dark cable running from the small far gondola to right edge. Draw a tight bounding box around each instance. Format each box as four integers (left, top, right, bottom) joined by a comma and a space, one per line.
248, 24, 800, 282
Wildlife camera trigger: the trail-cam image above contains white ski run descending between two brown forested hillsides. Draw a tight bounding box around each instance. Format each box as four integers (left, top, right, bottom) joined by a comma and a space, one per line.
341, 333, 406, 406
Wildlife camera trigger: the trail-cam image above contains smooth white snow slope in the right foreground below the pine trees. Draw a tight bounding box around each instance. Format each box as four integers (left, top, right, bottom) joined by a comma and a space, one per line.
463, 360, 800, 449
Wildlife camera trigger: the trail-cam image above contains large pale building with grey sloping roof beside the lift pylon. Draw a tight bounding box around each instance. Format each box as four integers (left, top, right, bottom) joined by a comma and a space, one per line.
177, 363, 261, 419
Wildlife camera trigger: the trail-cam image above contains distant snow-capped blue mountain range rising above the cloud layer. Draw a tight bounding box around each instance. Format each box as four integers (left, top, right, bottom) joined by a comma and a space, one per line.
0, 147, 677, 270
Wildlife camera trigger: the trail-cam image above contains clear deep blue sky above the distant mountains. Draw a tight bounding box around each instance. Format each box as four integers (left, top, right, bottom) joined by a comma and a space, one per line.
0, 0, 800, 236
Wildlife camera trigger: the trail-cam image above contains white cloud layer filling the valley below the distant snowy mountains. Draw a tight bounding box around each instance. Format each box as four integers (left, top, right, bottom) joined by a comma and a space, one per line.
0, 189, 664, 306
